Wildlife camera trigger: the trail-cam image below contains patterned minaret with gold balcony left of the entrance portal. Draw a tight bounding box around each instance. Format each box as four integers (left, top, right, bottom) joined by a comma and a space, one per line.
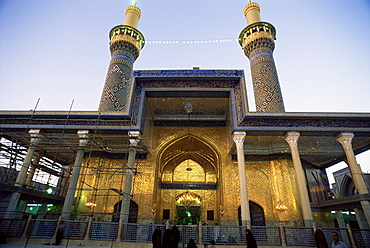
99, 4, 145, 113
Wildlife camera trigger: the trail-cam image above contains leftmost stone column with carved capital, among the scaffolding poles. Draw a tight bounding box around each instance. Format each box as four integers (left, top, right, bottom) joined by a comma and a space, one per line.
4, 129, 42, 218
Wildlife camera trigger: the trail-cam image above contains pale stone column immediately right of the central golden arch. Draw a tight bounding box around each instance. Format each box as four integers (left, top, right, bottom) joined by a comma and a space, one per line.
233, 132, 251, 228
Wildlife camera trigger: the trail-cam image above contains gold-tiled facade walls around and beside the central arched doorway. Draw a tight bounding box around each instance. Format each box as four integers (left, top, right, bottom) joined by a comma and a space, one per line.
77, 127, 304, 225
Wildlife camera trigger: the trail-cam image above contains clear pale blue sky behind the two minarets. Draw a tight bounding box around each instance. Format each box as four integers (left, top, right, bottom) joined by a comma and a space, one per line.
0, 0, 370, 178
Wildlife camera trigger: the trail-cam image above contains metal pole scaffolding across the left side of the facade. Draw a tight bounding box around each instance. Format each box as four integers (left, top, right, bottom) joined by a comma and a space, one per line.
0, 111, 147, 220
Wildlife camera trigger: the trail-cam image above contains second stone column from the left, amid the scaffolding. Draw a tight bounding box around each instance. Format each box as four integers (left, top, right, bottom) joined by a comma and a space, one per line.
61, 131, 89, 220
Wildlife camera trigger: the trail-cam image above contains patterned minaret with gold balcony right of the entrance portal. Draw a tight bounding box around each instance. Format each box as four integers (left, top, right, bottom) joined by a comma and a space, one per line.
239, 2, 285, 112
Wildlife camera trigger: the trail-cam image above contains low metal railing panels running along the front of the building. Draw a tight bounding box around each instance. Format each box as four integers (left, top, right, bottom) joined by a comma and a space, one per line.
0, 219, 370, 248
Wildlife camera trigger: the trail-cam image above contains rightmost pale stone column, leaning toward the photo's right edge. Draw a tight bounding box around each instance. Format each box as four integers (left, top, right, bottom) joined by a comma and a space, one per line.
337, 132, 370, 227
